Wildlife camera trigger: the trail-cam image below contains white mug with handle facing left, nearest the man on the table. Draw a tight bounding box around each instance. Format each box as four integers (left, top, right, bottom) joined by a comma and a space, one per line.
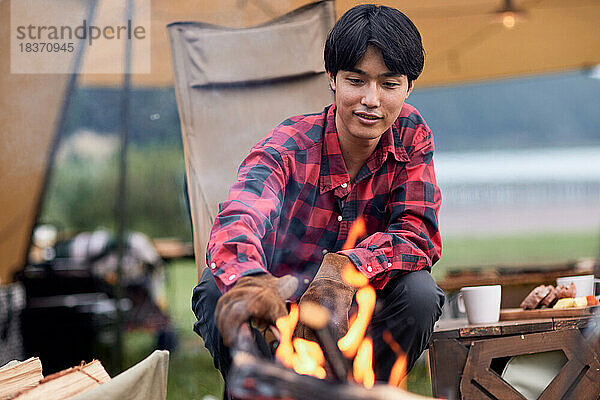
458, 285, 502, 324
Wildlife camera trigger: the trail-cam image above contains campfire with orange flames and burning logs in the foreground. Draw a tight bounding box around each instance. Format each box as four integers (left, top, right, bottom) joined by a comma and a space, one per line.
229, 219, 434, 400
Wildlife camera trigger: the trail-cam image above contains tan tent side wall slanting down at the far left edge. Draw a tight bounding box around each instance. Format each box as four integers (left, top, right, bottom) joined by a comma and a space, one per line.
0, 1, 86, 284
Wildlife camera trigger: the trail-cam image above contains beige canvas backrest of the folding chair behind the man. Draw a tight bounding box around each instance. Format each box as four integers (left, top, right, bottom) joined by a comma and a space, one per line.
168, 1, 335, 276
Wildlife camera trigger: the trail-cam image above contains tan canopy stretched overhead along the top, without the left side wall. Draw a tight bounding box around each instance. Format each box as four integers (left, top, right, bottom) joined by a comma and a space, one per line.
82, 0, 600, 88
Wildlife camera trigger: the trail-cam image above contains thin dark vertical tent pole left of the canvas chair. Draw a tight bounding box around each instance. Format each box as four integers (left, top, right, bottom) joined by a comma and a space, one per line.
114, 0, 134, 371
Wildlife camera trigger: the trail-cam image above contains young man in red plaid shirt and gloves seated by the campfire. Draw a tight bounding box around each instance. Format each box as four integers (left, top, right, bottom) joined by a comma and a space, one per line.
192, 5, 444, 380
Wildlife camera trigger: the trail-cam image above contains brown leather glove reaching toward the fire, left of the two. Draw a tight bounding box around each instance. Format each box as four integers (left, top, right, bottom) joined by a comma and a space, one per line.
215, 273, 298, 347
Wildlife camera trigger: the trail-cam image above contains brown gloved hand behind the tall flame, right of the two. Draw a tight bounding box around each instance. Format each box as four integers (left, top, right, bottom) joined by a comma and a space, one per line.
294, 253, 358, 341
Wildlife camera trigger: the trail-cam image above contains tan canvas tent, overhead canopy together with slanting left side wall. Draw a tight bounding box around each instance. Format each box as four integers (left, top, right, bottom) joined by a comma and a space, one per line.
0, 0, 600, 282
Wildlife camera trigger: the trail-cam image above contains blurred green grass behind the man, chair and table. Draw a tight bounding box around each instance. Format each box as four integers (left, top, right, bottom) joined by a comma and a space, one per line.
125, 232, 600, 400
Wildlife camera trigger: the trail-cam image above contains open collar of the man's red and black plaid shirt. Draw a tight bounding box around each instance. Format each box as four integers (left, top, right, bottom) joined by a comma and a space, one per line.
319, 103, 409, 193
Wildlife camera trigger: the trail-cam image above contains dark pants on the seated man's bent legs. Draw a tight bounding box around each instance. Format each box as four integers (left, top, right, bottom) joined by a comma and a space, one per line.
192, 268, 444, 381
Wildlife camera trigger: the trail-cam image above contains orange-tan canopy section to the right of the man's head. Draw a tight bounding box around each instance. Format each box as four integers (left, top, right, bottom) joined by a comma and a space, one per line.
410, 0, 600, 88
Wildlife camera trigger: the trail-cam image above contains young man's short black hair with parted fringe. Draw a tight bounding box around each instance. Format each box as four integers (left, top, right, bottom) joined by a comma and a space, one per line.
325, 4, 425, 84
